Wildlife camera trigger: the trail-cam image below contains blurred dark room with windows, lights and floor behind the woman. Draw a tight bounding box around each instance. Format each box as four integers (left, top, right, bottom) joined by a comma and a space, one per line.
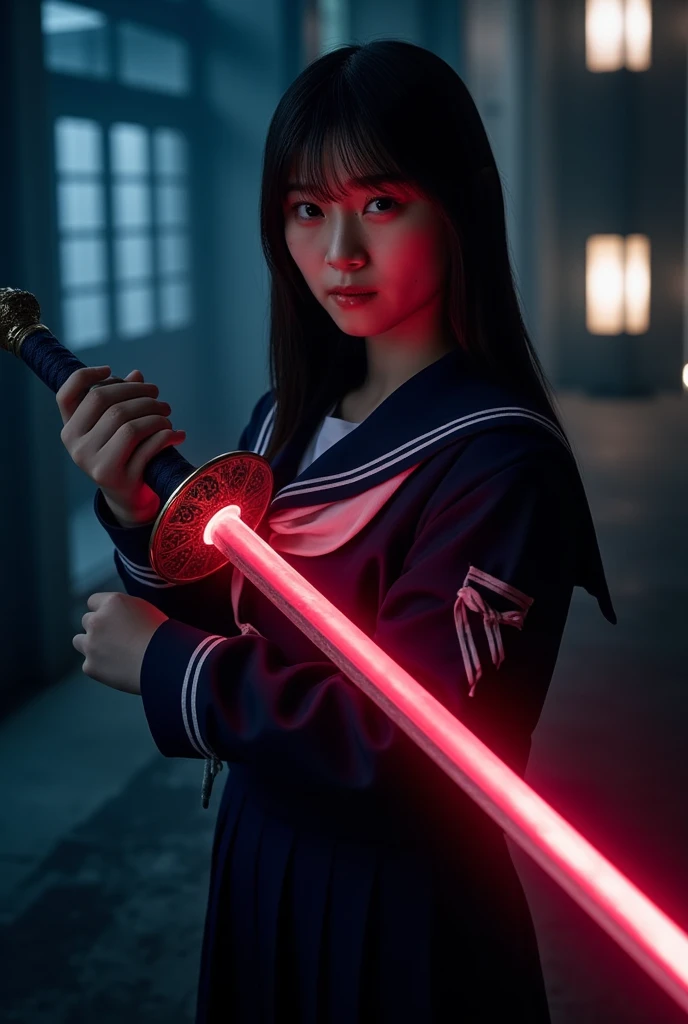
0, 0, 688, 1024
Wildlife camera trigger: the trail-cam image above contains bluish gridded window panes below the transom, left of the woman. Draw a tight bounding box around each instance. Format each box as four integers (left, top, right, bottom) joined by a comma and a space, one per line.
55, 117, 191, 351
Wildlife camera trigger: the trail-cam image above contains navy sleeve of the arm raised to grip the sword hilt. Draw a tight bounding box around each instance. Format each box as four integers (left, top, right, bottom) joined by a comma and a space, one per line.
93, 392, 269, 636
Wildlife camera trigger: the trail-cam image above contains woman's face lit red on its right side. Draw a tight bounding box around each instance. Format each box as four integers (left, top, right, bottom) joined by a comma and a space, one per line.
285, 159, 446, 342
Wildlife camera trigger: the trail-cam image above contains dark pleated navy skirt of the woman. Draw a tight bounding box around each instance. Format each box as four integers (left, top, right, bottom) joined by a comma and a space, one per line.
196, 765, 550, 1024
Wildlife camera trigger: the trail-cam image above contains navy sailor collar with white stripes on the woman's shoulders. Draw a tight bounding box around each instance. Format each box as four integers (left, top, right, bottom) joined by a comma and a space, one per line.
258, 349, 570, 511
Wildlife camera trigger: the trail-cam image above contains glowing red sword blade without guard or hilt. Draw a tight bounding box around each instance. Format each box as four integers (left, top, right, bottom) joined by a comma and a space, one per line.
204, 505, 688, 1011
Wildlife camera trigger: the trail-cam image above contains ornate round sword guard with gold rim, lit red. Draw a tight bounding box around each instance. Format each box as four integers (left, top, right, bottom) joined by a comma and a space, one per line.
148, 452, 272, 584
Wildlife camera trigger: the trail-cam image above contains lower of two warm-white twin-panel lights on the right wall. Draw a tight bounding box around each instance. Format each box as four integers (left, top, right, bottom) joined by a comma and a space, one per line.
586, 234, 650, 335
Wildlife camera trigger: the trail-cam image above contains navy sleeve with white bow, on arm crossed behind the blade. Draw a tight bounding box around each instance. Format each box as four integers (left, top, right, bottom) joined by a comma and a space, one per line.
141, 452, 575, 790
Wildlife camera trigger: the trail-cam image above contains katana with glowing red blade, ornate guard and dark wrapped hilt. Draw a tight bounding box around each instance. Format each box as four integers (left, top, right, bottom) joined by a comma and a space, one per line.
0, 289, 688, 1012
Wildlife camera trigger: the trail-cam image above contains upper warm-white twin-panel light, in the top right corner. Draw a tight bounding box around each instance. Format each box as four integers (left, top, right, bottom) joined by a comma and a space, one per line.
586, 0, 652, 72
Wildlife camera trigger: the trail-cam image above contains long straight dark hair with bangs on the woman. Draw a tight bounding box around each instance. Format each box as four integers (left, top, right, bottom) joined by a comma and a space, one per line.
260, 39, 563, 460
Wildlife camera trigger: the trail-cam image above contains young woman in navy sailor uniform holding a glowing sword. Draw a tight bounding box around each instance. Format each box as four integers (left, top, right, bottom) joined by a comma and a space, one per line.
64, 40, 615, 1024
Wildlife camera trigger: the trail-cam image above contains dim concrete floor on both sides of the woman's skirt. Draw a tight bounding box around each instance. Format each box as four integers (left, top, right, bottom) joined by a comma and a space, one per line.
0, 395, 688, 1024
